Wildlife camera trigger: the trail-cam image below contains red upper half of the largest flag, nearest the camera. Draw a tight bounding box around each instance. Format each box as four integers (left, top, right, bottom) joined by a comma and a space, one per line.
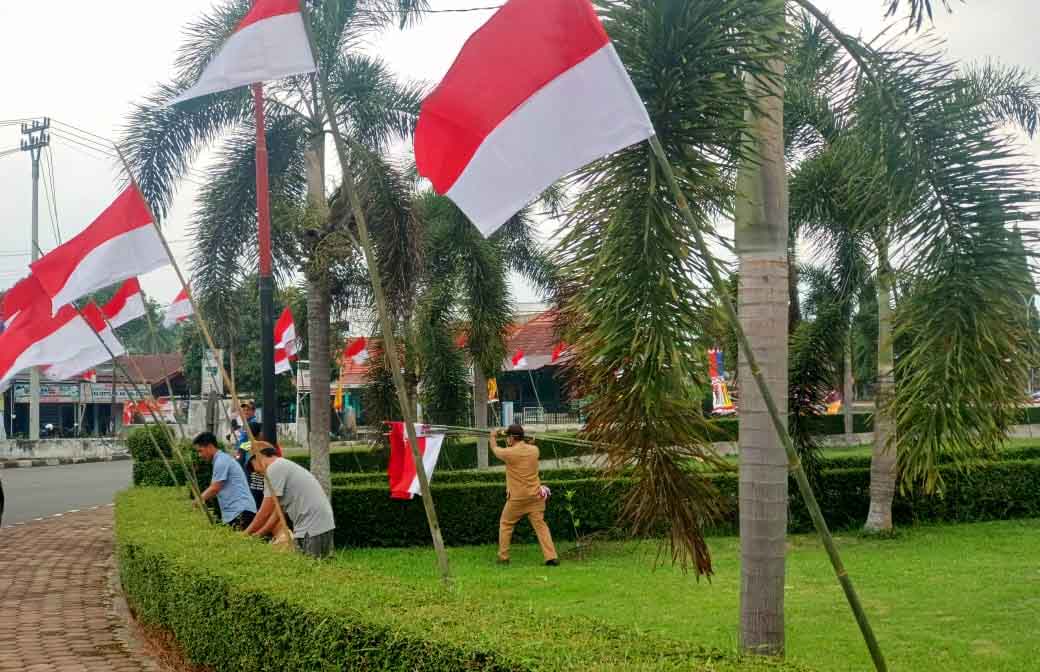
415, 0, 609, 193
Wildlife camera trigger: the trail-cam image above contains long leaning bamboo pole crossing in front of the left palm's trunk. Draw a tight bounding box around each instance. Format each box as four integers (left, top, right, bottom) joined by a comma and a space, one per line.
300, 1, 451, 584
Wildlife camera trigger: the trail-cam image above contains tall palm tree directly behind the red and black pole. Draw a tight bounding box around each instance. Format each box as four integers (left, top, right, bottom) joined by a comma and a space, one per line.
123, 0, 425, 490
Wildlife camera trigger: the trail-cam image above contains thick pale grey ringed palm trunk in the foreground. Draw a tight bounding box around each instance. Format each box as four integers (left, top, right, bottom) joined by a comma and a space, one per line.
735, 0, 789, 655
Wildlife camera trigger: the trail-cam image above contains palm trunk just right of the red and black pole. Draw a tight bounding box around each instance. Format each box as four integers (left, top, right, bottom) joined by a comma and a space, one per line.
304, 135, 332, 495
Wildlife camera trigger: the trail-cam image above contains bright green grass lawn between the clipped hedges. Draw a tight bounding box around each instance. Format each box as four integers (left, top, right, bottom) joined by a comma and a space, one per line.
338, 520, 1040, 672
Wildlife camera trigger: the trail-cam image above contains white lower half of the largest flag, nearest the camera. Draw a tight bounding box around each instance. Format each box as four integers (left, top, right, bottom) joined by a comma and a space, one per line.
446, 44, 653, 236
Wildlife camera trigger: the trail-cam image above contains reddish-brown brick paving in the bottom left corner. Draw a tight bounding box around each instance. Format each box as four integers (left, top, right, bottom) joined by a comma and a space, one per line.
0, 507, 162, 672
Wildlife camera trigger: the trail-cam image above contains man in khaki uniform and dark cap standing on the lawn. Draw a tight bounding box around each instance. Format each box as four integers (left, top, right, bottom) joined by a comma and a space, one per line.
491, 424, 560, 567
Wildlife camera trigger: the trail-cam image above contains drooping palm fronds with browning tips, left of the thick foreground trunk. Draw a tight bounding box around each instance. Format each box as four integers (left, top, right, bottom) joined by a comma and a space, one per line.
557, 0, 775, 574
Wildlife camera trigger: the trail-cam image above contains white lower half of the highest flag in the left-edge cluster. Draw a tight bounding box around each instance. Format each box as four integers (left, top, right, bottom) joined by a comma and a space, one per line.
51, 226, 170, 313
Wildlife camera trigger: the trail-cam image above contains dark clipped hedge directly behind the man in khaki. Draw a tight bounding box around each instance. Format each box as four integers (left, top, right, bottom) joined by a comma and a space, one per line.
333, 460, 1040, 546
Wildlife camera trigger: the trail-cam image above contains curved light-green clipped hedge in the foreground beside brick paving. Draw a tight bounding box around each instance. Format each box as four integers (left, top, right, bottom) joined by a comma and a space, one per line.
115, 488, 804, 672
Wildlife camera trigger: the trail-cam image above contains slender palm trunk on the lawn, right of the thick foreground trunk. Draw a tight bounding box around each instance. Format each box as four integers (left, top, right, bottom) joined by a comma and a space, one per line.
863, 238, 896, 533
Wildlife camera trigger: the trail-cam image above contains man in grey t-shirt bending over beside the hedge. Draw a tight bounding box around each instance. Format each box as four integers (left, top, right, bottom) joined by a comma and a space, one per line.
245, 442, 336, 558
